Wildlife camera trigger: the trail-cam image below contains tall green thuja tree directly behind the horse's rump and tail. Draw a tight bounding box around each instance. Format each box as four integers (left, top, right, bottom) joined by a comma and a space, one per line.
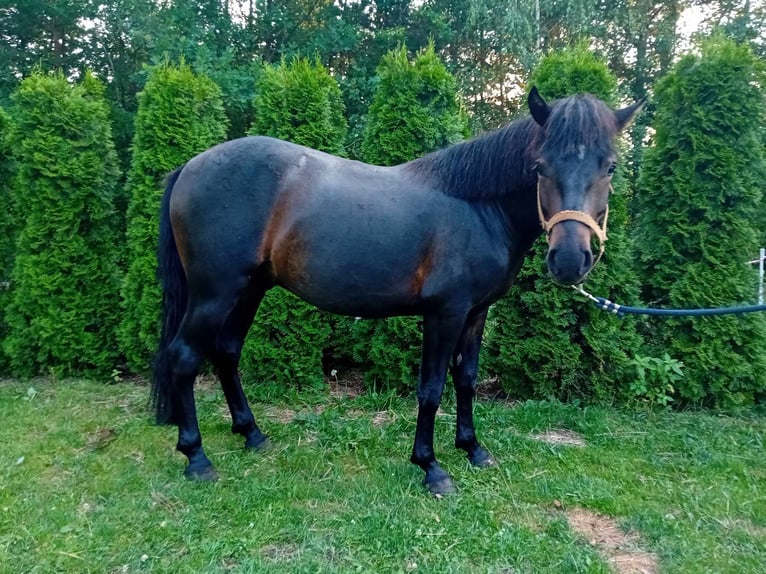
119, 63, 226, 372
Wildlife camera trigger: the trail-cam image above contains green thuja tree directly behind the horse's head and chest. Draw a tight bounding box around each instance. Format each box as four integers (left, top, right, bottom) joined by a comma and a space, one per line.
483, 45, 640, 400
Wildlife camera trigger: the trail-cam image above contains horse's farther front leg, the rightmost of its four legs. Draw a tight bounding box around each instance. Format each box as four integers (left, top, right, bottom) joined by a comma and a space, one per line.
452, 308, 495, 467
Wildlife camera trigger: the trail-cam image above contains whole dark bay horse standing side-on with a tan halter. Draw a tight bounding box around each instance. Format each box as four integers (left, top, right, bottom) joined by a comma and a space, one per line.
152, 88, 641, 494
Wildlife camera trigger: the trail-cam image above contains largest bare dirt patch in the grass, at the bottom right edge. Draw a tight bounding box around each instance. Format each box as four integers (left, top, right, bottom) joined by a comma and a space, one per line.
566, 508, 660, 574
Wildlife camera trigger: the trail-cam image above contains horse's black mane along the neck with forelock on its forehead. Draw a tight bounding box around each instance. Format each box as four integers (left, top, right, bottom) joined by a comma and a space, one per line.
405, 94, 617, 200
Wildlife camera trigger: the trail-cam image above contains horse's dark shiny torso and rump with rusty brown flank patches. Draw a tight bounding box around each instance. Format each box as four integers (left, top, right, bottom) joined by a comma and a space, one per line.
171, 137, 510, 316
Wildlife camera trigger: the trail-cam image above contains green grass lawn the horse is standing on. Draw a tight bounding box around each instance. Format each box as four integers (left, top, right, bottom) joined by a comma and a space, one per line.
0, 381, 766, 574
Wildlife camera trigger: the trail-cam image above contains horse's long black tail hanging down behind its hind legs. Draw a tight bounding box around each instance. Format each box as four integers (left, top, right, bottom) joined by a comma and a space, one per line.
152, 166, 188, 424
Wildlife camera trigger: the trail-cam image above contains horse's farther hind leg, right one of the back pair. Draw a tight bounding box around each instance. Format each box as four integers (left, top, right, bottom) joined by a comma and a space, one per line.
212, 285, 268, 450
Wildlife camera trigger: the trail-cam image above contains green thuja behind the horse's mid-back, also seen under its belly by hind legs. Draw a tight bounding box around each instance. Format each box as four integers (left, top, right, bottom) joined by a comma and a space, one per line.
240, 58, 347, 386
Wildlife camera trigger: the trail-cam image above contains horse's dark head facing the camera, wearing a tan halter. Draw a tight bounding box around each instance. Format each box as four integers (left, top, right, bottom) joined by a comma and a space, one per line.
528, 87, 643, 285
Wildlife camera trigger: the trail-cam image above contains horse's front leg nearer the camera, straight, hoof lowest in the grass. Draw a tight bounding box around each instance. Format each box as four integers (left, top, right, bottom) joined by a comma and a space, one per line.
410, 315, 465, 495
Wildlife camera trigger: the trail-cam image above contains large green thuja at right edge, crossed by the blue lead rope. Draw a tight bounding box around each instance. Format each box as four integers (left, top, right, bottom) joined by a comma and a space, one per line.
636, 38, 766, 406
